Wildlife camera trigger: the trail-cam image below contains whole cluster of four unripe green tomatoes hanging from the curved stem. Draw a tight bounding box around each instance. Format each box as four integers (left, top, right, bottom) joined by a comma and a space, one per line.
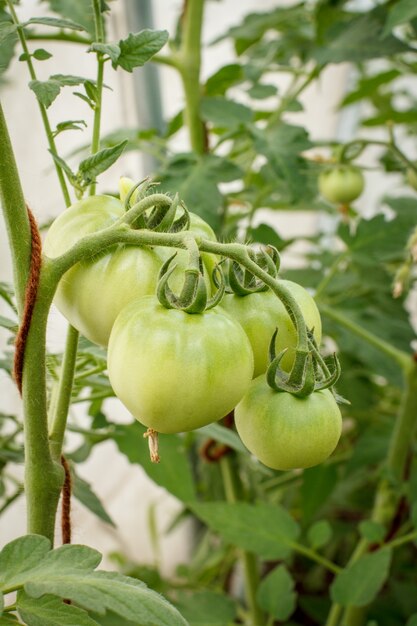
44, 190, 341, 470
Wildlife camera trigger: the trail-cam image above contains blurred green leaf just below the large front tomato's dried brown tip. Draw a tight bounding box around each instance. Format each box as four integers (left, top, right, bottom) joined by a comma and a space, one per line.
114, 422, 196, 502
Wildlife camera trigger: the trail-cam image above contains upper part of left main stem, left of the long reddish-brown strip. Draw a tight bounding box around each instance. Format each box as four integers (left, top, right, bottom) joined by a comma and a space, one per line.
0, 103, 31, 317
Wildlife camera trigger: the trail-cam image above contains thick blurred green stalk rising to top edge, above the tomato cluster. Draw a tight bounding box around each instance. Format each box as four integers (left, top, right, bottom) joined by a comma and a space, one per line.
178, 0, 206, 154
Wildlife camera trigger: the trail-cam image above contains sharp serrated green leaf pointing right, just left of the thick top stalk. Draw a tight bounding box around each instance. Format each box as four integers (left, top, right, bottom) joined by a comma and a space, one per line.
113, 29, 168, 72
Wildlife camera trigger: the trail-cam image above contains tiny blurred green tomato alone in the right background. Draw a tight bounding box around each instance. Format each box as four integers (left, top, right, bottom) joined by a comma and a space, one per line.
319, 165, 365, 204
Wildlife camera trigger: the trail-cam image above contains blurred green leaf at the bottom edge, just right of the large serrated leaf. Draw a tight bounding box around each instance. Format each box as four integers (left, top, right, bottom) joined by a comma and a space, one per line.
175, 591, 236, 626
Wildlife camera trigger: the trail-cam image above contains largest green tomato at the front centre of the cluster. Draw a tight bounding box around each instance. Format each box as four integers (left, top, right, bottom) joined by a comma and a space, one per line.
108, 296, 253, 433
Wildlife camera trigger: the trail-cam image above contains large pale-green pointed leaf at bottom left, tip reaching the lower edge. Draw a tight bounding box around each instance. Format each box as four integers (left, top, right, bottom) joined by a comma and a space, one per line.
25, 572, 187, 626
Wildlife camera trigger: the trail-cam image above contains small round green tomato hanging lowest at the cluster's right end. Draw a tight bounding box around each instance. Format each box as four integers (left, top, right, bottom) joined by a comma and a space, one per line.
235, 376, 342, 470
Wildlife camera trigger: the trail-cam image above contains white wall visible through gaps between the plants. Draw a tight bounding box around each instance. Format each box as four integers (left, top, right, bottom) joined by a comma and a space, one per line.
0, 0, 396, 571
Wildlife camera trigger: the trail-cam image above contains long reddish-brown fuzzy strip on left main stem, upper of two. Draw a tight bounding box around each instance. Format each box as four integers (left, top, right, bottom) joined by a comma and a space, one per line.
13, 205, 42, 394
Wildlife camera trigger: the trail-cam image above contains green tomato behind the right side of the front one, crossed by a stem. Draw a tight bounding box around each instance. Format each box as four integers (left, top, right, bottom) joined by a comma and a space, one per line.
221, 280, 321, 377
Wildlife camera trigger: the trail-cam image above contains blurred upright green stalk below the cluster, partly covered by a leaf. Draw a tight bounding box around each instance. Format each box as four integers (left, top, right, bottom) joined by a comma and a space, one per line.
220, 456, 264, 626
